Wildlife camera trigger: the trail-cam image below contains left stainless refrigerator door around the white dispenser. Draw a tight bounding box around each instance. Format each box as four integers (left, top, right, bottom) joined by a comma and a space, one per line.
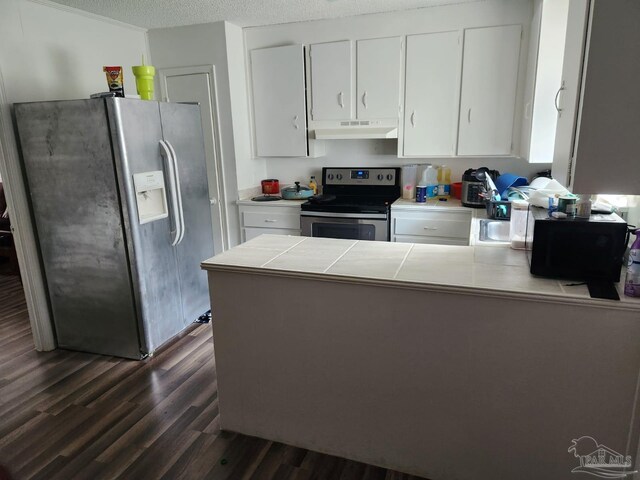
105, 98, 185, 353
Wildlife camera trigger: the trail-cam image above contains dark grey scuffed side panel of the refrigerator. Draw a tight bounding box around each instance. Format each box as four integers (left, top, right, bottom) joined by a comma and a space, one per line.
15, 100, 140, 358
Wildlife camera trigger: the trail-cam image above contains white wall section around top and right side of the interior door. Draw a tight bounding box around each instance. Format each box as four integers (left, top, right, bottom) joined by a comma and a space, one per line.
148, 22, 266, 246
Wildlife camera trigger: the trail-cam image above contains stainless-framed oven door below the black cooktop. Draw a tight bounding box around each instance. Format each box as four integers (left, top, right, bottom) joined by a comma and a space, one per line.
300, 212, 389, 242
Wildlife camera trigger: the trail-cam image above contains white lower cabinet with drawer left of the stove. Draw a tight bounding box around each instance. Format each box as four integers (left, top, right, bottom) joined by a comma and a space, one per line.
239, 202, 300, 242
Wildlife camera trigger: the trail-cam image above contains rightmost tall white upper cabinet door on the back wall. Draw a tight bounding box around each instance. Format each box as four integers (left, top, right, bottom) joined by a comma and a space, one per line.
458, 25, 522, 155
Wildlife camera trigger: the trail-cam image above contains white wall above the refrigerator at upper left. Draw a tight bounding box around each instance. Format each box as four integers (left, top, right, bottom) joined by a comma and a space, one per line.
0, 0, 149, 102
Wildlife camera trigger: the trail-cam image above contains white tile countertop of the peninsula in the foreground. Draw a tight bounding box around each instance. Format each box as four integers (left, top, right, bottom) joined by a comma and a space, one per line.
202, 235, 640, 312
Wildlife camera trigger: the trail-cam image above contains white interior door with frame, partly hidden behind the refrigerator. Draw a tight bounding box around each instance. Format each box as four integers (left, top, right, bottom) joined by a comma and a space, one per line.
159, 66, 229, 255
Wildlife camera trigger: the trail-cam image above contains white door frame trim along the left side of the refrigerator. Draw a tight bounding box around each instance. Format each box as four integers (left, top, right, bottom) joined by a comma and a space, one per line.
0, 66, 57, 351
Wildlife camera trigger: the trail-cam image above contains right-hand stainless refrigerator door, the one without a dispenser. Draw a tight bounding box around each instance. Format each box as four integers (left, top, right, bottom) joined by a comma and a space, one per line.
160, 103, 213, 325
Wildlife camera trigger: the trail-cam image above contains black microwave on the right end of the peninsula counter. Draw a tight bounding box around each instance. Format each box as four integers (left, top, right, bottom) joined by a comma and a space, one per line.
526, 207, 628, 283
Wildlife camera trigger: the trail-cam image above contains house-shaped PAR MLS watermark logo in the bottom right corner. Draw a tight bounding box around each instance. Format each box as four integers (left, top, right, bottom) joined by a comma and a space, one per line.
568, 437, 637, 478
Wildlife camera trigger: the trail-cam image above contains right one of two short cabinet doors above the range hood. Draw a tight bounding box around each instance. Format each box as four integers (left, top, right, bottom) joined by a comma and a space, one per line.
356, 37, 402, 120
